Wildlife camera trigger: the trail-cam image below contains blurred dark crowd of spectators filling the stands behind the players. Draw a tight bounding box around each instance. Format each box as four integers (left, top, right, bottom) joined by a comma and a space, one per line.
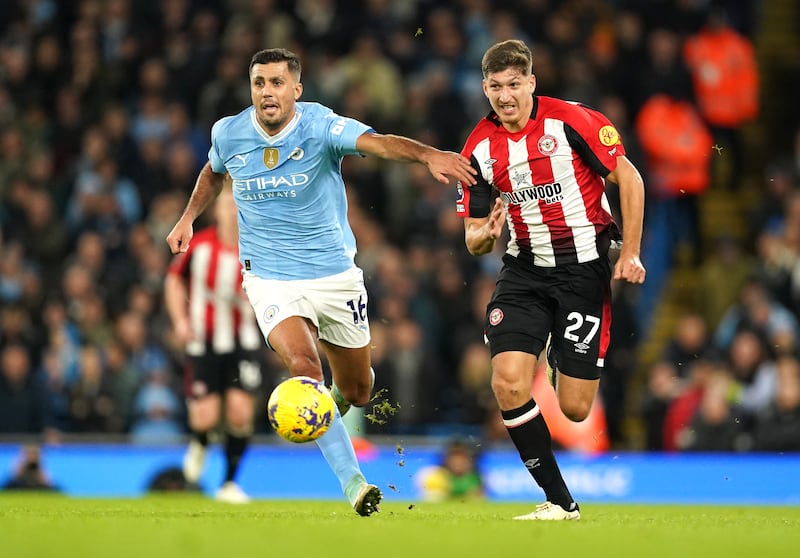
0, 0, 800, 451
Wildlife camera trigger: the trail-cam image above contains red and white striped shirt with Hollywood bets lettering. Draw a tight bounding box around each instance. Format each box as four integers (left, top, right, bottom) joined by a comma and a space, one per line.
456, 96, 625, 267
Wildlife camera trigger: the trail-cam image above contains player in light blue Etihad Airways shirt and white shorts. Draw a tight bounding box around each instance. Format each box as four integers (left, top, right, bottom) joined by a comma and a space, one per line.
167, 49, 475, 516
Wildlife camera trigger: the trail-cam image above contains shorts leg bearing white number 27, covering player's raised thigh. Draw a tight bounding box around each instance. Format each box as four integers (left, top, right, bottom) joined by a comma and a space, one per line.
551, 258, 611, 382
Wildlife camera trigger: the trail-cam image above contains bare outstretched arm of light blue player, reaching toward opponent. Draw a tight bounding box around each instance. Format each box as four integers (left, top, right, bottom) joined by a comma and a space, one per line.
356, 132, 477, 185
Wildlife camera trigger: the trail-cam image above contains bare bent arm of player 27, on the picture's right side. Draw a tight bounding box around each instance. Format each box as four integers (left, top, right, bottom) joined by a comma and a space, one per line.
607, 156, 646, 283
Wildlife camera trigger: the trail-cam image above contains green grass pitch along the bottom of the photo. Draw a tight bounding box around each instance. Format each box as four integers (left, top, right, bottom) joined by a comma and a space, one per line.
0, 493, 800, 558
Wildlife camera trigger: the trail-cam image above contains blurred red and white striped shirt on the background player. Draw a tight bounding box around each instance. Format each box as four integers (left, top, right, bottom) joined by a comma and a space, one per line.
167, 230, 262, 356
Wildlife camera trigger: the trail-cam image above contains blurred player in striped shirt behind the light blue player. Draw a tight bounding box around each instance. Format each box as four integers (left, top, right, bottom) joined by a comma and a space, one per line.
164, 189, 263, 504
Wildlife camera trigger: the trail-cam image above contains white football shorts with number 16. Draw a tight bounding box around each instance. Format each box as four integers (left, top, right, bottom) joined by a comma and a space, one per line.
242, 267, 370, 349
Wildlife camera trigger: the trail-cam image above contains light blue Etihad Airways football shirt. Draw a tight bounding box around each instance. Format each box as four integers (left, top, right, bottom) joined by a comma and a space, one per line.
208, 103, 372, 279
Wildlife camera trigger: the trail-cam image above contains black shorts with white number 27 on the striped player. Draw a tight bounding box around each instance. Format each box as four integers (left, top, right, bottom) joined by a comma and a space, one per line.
485, 255, 611, 380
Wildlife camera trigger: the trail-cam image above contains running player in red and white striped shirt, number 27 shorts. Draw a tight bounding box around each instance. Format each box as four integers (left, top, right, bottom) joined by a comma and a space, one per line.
457, 40, 648, 520
